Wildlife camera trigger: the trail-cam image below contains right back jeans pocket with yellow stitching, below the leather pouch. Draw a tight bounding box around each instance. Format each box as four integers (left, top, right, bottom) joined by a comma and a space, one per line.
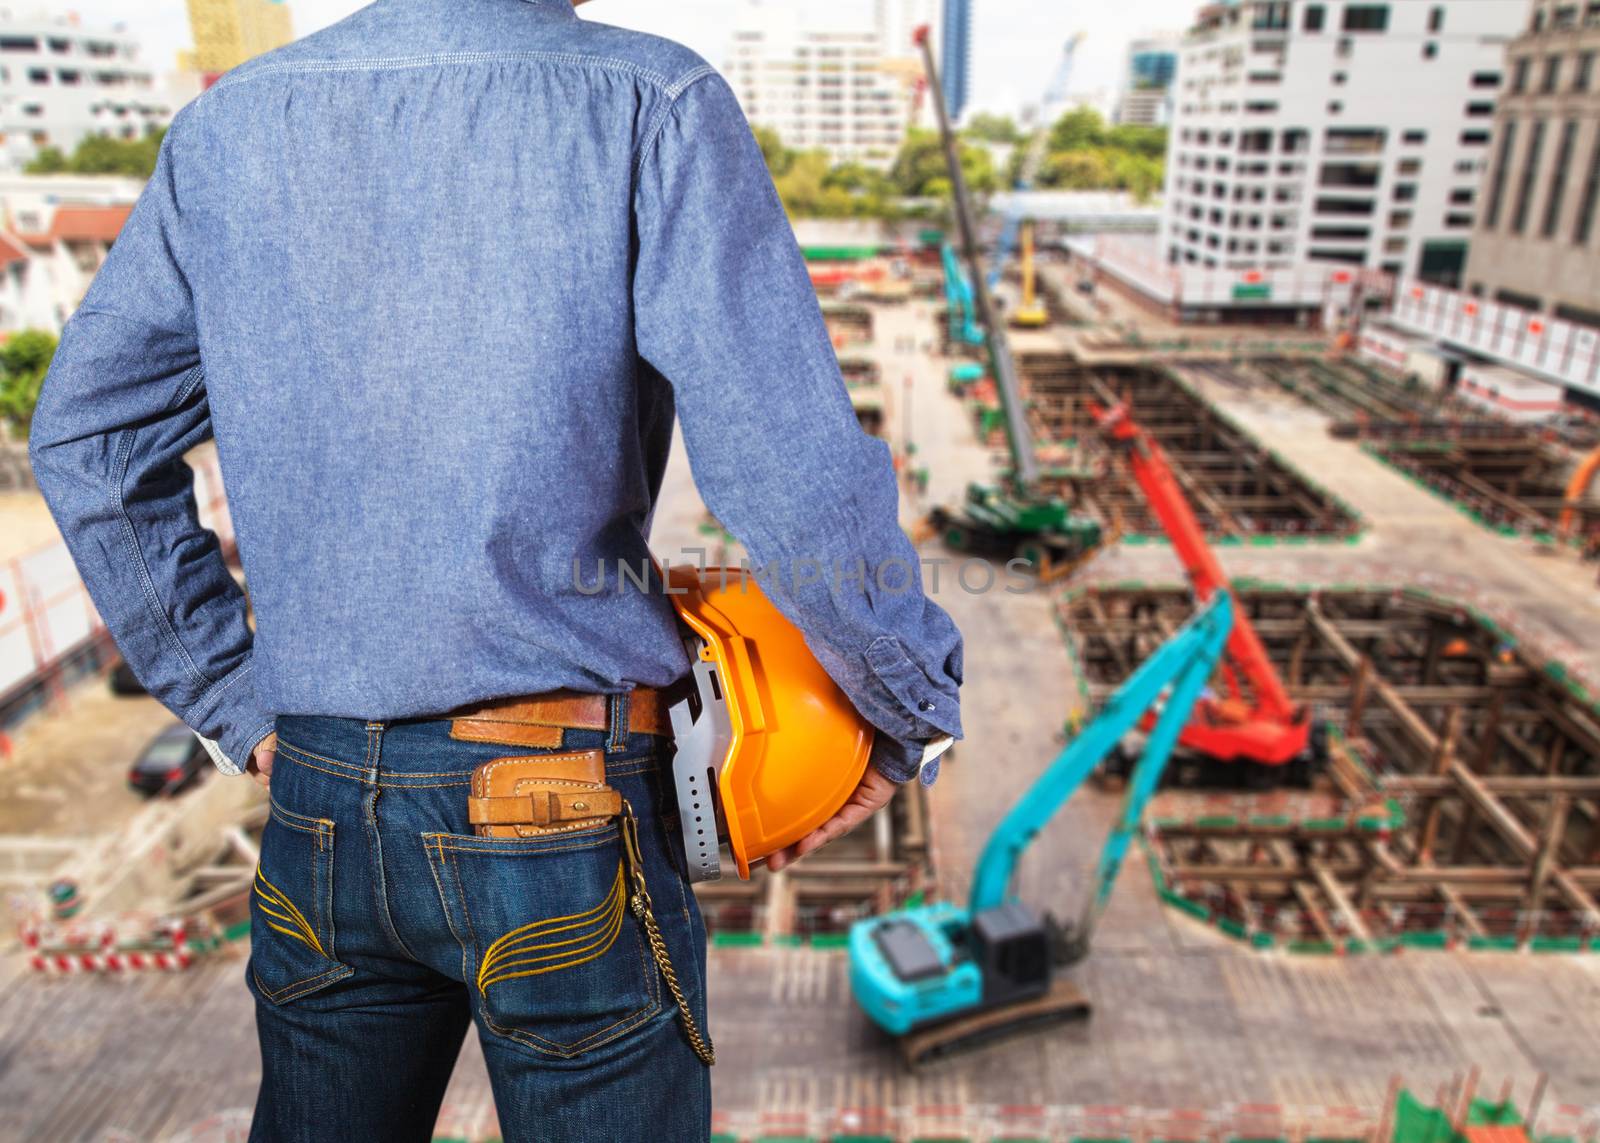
422, 823, 661, 1058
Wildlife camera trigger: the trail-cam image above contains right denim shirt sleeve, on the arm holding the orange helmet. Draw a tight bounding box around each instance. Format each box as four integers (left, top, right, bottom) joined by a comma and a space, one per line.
634, 67, 962, 783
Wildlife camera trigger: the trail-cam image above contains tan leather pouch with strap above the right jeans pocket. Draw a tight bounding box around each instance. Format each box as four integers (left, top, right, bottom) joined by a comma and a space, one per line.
467, 749, 622, 837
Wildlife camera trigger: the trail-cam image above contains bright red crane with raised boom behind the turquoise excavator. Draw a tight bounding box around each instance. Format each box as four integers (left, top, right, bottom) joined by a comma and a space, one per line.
1090, 394, 1326, 786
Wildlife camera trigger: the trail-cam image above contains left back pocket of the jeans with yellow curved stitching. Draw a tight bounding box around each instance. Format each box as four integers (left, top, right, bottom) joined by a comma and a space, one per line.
250, 799, 354, 1004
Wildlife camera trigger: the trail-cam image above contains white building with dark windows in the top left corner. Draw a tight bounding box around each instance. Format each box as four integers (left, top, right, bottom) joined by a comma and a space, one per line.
0, 11, 173, 171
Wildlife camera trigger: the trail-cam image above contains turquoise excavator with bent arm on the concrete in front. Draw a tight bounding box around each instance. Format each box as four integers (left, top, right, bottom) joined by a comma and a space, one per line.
850, 591, 1234, 1065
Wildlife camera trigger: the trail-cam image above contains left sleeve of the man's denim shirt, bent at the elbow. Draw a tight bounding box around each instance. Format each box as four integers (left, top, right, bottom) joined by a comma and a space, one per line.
29, 118, 272, 773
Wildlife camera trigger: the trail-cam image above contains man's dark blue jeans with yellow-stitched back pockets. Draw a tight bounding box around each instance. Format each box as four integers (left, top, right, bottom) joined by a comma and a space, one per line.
246, 716, 710, 1143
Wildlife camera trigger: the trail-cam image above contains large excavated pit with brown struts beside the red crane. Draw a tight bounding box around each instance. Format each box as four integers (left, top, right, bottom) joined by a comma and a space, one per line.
1062, 588, 1600, 951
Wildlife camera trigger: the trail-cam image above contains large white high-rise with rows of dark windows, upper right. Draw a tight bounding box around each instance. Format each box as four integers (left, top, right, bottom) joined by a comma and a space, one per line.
1162, 0, 1528, 285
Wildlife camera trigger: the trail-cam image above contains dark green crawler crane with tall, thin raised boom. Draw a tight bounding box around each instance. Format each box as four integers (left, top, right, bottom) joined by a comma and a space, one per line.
915, 26, 1101, 578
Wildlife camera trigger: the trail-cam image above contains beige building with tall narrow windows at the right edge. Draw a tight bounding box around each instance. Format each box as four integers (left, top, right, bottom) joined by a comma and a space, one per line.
1466, 0, 1600, 327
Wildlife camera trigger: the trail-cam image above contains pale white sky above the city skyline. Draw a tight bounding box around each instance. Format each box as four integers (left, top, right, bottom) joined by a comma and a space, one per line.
62, 0, 1200, 114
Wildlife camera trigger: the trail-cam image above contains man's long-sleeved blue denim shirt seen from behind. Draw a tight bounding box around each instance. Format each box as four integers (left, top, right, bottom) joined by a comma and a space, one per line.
29, 0, 962, 781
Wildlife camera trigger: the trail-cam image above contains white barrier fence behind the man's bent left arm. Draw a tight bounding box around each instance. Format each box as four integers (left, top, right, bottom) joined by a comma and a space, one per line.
0, 447, 234, 728
